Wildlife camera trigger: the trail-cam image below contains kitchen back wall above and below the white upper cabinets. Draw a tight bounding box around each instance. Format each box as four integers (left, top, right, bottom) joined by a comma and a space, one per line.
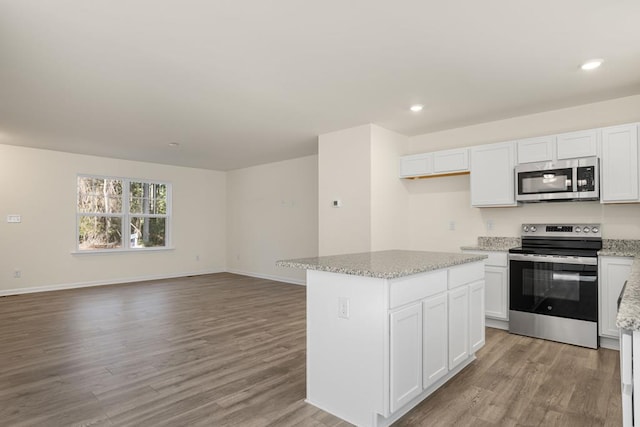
404, 95, 640, 251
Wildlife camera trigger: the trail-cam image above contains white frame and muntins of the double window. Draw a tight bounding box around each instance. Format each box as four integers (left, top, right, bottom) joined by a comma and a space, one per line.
73, 173, 173, 254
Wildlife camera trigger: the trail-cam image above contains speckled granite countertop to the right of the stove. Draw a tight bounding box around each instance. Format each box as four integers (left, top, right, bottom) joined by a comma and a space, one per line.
598, 239, 640, 331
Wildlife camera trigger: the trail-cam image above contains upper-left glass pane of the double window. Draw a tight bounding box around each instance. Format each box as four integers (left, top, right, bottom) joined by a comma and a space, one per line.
78, 177, 122, 213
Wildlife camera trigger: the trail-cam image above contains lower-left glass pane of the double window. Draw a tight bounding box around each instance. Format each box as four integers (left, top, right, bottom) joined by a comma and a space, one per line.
78, 215, 122, 250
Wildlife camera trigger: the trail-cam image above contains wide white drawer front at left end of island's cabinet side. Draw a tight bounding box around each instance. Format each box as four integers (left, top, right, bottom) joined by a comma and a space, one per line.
389, 270, 447, 308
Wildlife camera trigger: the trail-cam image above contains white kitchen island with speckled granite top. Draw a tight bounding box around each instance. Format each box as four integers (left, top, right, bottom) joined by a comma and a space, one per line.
277, 251, 486, 427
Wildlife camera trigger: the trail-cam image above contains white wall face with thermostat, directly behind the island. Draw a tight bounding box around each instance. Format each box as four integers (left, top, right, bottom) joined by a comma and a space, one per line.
318, 125, 371, 255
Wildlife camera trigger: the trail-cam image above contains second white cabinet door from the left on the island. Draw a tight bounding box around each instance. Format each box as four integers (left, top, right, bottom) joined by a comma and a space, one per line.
422, 292, 449, 389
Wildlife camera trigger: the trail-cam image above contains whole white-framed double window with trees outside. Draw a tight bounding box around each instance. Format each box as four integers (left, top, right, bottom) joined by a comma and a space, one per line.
76, 175, 171, 251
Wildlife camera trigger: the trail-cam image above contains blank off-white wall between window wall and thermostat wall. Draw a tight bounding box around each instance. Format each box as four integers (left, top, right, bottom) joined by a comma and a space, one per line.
227, 156, 318, 283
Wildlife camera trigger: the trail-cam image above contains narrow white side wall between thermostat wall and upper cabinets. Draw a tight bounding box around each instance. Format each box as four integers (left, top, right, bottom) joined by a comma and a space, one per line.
370, 125, 409, 251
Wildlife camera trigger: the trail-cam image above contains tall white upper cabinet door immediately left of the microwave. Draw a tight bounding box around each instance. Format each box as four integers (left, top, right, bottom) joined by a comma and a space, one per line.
471, 142, 516, 207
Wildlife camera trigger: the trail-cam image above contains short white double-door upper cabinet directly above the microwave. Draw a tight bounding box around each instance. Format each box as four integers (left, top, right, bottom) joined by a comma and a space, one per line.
517, 129, 599, 164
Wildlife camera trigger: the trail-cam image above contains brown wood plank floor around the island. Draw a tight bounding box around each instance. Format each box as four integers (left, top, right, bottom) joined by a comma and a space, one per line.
0, 273, 622, 427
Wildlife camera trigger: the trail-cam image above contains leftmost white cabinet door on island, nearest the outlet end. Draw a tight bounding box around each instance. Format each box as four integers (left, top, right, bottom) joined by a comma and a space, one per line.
390, 303, 422, 412
